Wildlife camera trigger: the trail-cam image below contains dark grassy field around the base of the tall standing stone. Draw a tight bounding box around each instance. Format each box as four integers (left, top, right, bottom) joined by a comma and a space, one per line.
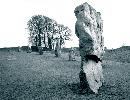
0, 51, 130, 100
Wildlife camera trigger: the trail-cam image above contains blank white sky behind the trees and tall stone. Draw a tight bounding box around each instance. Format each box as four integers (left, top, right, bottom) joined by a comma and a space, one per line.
0, 0, 130, 48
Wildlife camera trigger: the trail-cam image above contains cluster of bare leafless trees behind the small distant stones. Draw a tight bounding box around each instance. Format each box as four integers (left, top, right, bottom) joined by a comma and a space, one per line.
27, 15, 71, 56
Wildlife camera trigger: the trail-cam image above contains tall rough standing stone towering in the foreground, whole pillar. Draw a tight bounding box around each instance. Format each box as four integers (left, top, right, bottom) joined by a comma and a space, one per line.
74, 3, 104, 93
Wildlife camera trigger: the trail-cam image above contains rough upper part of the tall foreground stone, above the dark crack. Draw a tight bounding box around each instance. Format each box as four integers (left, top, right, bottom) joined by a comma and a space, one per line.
75, 3, 104, 58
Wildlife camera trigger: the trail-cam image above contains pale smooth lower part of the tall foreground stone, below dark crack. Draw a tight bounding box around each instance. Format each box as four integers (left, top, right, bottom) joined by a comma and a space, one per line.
81, 60, 103, 94
